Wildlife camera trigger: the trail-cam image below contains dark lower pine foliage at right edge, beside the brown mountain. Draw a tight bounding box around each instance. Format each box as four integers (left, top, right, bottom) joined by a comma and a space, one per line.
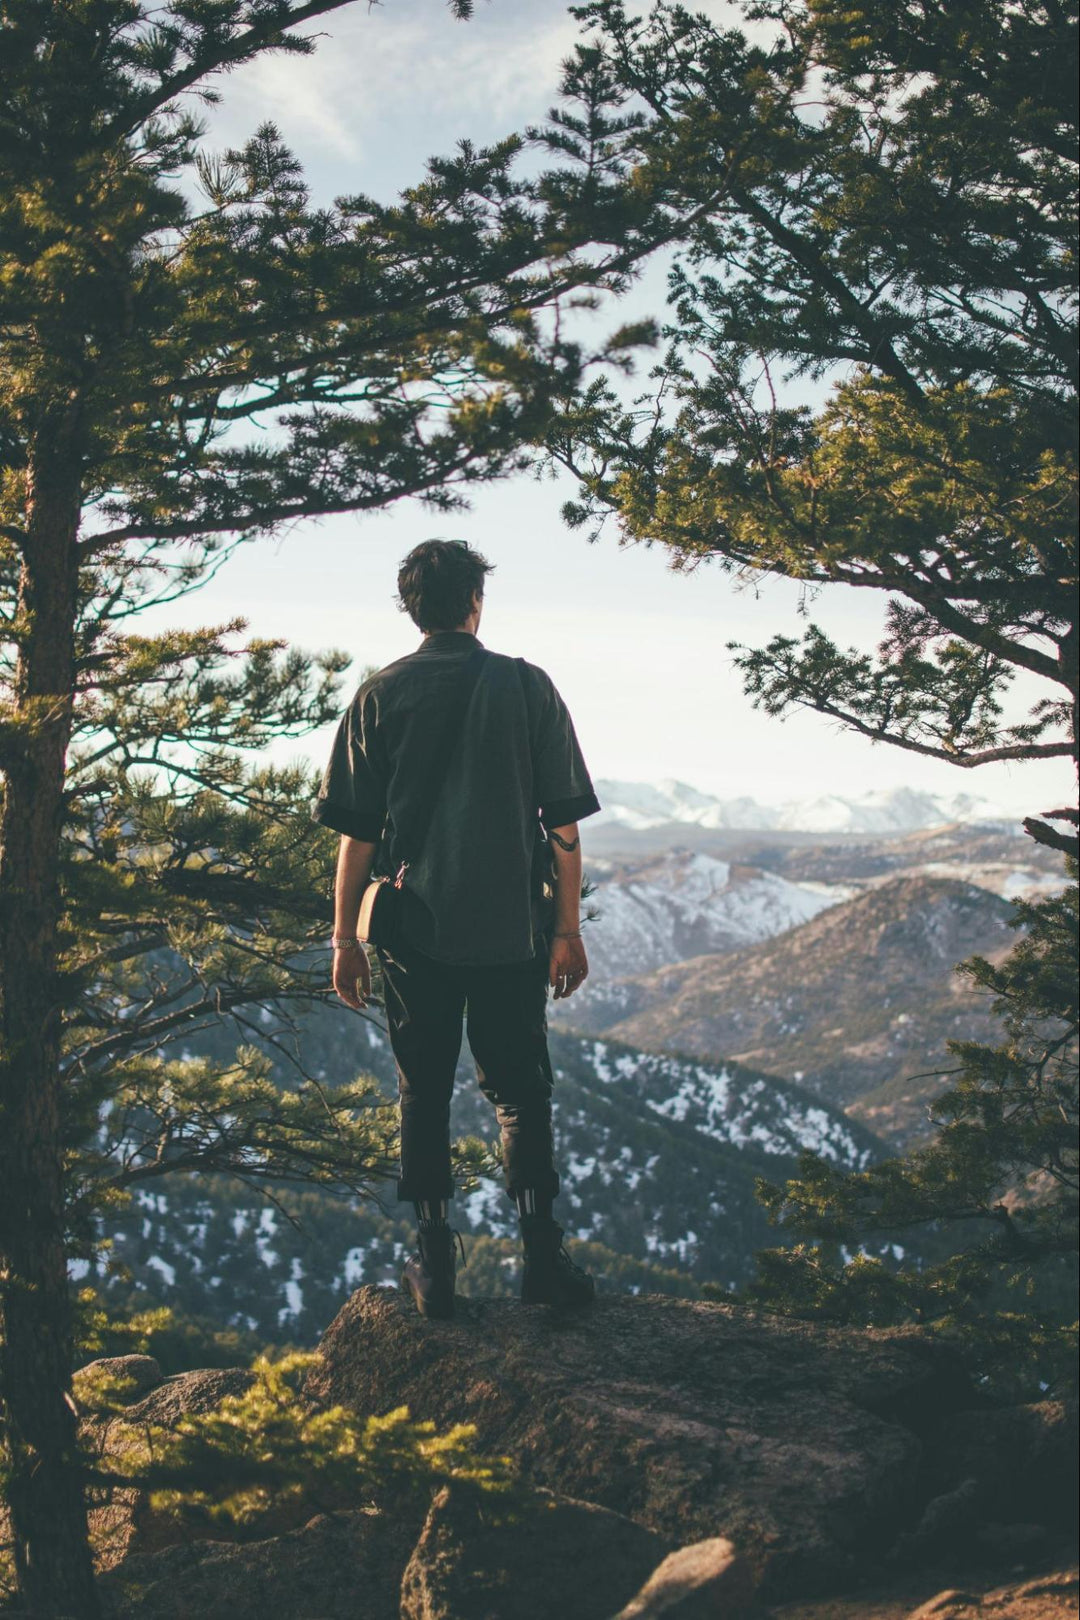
751, 860, 1080, 1395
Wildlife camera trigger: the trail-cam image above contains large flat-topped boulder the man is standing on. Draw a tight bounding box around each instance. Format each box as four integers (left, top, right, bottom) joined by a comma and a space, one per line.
308, 1286, 975, 1612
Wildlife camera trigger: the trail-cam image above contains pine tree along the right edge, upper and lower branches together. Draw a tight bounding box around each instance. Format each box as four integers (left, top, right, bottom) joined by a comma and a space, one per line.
549, 0, 1080, 1388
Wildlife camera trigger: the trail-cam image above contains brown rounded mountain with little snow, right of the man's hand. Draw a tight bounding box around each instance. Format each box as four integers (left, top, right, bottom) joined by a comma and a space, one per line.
559, 872, 1015, 1145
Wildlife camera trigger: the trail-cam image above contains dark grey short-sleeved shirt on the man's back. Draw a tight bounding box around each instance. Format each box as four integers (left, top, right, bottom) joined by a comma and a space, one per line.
311, 630, 601, 966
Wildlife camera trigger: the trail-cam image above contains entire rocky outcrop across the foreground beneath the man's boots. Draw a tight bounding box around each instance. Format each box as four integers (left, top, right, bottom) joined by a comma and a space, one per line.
76, 1288, 1075, 1620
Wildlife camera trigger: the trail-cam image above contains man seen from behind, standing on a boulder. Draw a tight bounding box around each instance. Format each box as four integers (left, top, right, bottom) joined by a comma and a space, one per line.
311, 539, 599, 1317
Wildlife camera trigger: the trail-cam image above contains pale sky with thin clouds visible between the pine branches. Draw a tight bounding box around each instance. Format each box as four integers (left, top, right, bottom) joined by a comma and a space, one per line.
132, 0, 1070, 812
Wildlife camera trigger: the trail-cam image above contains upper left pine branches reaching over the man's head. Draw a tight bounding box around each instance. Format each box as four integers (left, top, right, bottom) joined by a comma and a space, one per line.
0, 0, 663, 576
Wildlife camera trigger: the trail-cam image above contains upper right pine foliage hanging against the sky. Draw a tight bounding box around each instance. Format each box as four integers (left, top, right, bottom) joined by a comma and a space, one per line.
549, 0, 1078, 787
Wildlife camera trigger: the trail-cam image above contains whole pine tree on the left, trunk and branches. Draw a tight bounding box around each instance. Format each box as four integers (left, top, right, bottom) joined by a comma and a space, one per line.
0, 9, 651, 1617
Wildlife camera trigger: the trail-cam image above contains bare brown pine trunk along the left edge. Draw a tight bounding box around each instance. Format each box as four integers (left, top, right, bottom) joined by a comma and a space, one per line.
0, 439, 100, 1620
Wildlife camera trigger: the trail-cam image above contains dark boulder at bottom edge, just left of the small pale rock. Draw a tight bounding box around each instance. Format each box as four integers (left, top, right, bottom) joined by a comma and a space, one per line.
400, 1486, 665, 1620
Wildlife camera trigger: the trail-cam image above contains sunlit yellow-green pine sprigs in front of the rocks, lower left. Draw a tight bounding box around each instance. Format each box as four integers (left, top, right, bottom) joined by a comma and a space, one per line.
81, 1351, 513, 1539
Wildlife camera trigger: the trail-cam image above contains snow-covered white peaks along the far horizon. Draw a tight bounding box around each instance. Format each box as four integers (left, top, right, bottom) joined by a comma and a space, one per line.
589, 779, 1020, 836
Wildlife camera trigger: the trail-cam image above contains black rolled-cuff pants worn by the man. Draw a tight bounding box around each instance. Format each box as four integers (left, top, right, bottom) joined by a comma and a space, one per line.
379, 941, 559, 1199
